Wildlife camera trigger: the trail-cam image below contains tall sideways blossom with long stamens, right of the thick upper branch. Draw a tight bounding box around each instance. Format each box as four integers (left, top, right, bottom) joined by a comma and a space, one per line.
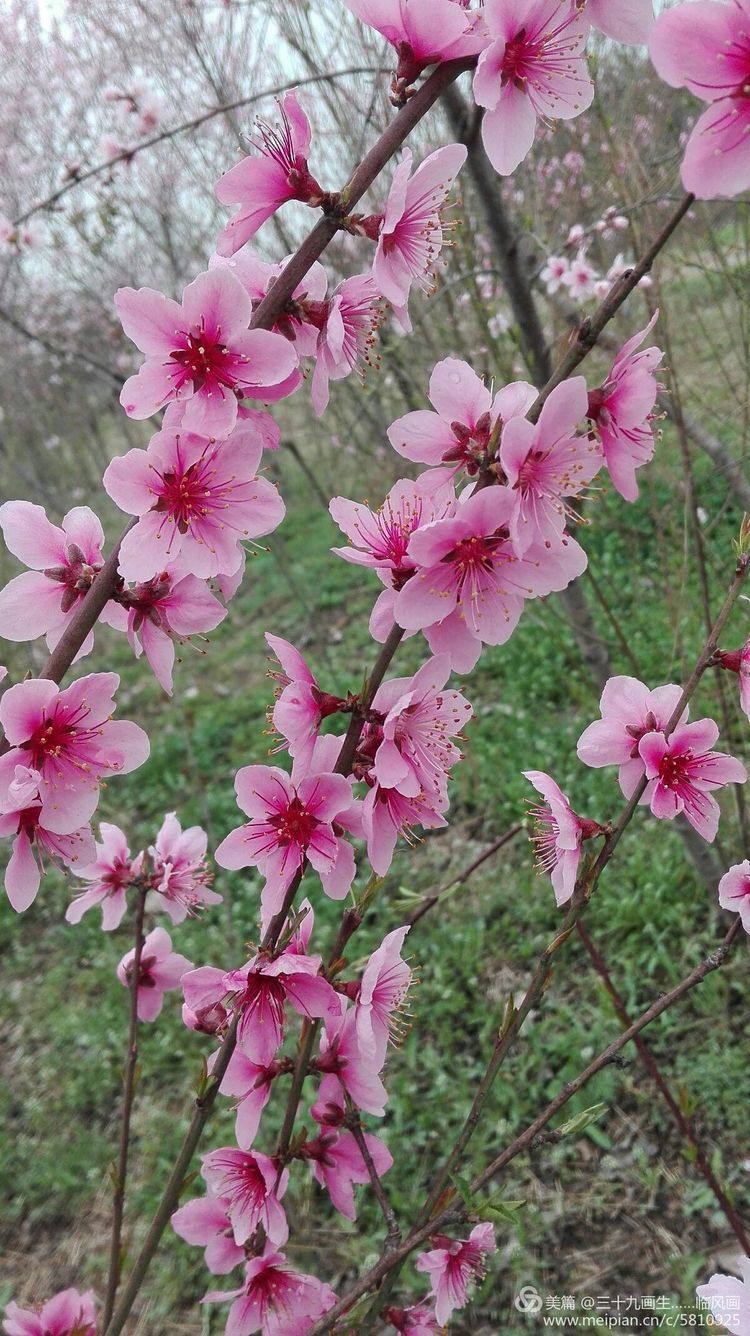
373, 144, 467, 307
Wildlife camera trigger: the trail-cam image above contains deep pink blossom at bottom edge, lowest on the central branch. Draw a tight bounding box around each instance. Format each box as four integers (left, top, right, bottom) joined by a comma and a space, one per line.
203, 1246, 336, 1336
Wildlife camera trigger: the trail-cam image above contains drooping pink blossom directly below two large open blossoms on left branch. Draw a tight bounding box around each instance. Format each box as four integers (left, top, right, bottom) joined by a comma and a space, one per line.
119, 566, 226, 696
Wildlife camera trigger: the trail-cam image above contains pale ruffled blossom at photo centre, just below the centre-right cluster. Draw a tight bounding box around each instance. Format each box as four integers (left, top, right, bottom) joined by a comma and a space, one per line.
372, 655, 472, 798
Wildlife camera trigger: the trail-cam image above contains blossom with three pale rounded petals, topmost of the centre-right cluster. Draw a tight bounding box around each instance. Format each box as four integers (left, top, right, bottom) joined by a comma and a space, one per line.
388, 357, 536, 476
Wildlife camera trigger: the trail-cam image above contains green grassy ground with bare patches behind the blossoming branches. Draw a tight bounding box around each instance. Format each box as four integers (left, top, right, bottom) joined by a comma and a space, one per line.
0, 390, 750, 1336
